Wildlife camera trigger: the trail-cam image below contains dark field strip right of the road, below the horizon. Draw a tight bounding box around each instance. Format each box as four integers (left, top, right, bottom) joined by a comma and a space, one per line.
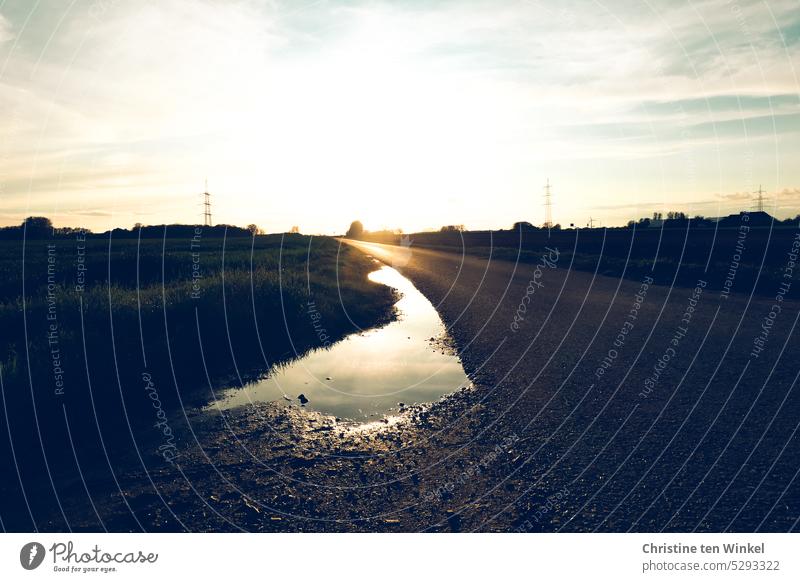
364, 222, 798, 295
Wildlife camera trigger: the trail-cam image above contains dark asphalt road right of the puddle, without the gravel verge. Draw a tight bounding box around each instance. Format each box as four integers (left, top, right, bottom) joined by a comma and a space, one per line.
340, 238, 800, 531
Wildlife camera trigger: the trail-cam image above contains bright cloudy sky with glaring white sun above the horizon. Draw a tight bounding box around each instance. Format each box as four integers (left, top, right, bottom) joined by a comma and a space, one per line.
0, 0, 800, 233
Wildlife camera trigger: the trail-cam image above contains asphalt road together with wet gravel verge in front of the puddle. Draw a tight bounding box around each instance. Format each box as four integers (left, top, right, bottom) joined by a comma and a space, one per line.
45, 245, 800, 531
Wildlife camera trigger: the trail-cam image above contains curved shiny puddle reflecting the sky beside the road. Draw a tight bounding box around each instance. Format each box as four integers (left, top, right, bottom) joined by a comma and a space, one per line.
209, 266, 468, 420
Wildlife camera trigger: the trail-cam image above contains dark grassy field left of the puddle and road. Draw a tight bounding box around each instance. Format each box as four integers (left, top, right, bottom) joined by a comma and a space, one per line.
0, 232, 395, 502
